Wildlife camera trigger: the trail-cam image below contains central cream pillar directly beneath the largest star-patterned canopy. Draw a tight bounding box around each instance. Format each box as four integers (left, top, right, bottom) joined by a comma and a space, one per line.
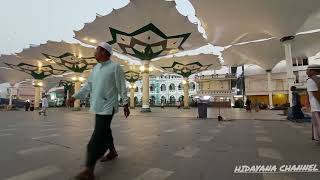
141, 61, 151, 112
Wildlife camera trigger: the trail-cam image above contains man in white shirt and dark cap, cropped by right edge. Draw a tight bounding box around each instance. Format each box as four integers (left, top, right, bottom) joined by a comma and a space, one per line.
307, 65, 320, 141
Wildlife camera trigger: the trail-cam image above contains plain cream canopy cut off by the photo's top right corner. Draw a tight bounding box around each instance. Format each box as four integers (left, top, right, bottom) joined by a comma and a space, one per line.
190, 0, 320, 46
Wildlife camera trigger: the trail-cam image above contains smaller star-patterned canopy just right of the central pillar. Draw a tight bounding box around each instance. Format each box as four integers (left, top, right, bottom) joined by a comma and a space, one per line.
152, 54, 221, 77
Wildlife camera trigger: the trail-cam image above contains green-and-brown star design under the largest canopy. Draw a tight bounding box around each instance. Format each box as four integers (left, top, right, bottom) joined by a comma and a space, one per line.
108, 23, 191, 60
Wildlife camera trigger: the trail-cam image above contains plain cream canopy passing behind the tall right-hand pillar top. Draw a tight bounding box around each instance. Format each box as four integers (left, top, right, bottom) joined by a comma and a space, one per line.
222, 32, 320, 70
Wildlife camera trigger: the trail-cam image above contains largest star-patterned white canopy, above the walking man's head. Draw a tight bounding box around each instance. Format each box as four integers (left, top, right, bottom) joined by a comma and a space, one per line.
75, 0, 207, 60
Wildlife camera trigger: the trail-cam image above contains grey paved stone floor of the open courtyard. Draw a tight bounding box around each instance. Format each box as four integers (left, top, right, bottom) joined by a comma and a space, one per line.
0, 108, 320, 180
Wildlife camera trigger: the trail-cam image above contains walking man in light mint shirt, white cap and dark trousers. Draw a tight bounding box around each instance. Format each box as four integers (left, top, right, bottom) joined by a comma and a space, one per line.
72, 42, 130, 180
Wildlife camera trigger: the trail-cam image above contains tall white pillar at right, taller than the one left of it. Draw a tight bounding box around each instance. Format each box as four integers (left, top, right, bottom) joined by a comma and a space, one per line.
283, 40, 294, 107
